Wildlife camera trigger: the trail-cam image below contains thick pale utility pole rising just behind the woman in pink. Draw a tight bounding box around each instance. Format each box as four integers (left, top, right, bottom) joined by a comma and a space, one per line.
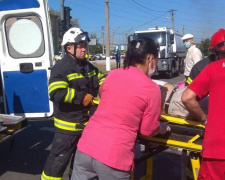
105, 0, 111, 71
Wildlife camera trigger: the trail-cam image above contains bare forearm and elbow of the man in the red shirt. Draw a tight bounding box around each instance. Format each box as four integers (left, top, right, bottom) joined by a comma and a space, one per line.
181, 88, 207, 123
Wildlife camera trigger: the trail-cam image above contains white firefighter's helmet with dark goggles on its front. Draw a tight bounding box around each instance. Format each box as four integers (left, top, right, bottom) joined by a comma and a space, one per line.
61, 27, 90, 46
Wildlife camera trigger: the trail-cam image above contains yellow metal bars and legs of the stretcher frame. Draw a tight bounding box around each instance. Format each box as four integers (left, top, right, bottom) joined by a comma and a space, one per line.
131, 115, 205, 180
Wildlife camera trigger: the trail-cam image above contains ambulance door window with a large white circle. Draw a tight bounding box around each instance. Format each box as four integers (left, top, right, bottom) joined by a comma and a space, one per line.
5, 16, 44, 58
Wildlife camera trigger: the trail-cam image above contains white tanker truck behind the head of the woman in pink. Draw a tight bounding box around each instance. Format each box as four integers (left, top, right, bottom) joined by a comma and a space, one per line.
128, 27, 186, 78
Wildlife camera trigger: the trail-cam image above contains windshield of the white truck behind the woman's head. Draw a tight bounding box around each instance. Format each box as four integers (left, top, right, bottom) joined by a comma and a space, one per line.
135, 32, 166, 46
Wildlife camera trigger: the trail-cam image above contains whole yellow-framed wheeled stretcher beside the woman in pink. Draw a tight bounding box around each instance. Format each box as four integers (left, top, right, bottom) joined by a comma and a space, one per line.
131, 115, 205, 180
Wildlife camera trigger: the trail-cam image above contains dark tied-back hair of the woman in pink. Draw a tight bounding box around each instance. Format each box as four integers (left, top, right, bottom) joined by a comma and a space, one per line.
123, 37, 158, 69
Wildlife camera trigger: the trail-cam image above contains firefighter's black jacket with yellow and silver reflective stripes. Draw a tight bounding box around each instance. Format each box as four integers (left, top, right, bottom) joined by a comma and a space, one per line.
49, 54, 105, 134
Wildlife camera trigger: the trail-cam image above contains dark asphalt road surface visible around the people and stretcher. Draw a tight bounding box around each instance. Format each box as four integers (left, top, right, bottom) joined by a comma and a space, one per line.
0, 72, 184, 180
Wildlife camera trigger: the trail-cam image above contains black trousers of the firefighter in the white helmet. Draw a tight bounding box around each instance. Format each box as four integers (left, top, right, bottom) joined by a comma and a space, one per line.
41, 132, 80, 179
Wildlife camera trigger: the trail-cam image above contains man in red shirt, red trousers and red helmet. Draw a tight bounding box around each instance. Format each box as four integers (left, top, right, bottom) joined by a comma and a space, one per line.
182, 29, 225, 180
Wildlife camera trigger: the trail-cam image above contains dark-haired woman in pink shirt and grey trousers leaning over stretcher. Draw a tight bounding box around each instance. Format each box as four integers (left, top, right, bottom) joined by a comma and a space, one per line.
71, 38, 166, 180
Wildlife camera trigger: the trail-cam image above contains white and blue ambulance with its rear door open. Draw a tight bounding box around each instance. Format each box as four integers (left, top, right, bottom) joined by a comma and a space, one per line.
0, 0, 54, 142
